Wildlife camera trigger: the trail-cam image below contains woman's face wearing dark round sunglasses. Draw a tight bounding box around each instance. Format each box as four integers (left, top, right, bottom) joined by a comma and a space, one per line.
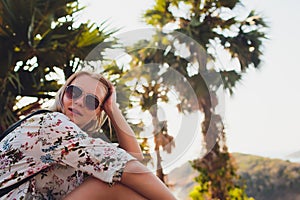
63, 74, 107, 128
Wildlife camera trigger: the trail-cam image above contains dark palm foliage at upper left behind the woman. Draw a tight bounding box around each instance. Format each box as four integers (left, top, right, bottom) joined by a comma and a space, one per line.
0, 0, 114, 133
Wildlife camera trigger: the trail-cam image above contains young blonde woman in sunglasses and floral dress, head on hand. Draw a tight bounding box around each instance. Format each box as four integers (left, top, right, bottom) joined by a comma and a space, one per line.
0, 71, 175, 200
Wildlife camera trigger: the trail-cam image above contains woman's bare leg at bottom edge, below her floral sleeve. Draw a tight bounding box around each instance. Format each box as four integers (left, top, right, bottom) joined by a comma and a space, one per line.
64, 177, 145, 200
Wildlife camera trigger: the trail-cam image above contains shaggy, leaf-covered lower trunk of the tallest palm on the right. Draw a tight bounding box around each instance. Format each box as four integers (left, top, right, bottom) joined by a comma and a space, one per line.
192, 95, 237, 200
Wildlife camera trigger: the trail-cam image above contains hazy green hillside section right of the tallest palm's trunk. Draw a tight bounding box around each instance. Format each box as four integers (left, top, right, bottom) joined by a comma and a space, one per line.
233, 153, 300, 200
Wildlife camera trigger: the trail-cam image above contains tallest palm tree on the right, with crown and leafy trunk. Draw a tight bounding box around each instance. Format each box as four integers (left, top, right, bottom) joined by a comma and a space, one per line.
123, 0, 267, 199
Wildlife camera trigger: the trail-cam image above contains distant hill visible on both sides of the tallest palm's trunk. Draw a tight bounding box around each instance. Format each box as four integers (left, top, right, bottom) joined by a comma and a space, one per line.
168, 153, 300, 200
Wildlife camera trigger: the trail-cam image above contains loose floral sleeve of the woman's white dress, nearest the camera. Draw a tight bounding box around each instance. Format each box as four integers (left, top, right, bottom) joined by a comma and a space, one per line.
30, 112, 135, 183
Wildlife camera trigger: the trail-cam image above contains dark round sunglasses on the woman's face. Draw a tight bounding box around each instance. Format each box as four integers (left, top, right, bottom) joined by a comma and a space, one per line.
65, 85, 100, 110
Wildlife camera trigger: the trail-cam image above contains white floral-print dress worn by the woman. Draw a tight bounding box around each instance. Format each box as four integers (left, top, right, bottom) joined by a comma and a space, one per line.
0, 112, 134, 199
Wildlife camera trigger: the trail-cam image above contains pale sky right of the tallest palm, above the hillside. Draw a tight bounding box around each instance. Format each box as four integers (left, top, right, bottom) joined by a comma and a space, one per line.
226, 0, 300, 157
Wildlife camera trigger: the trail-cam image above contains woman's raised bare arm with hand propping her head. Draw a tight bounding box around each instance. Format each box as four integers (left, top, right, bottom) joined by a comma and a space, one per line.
104, 86, 143, 161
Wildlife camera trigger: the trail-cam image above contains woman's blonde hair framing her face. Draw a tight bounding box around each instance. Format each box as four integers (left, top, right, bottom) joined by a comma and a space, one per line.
49, 71, 112, 133
